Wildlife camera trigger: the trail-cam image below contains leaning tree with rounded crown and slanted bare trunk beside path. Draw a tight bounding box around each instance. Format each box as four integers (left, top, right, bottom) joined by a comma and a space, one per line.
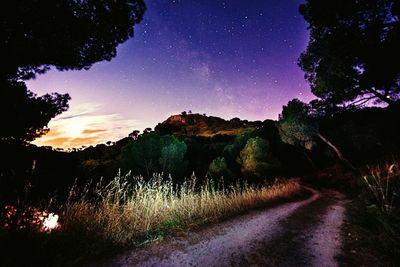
277, 99, 354, 169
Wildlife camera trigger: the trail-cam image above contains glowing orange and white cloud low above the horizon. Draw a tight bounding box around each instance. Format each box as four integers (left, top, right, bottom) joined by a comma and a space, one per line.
33, 103, 143, 149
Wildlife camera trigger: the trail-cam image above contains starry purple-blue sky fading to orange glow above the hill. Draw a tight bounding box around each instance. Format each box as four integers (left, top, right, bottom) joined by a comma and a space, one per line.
28, 0, 313, 148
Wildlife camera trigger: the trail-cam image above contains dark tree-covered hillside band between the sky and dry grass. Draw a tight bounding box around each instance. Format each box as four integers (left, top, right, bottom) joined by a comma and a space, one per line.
0, 105, 400, 204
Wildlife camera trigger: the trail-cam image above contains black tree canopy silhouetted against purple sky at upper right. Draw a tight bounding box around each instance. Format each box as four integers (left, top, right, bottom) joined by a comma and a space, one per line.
299, 0, 400, 106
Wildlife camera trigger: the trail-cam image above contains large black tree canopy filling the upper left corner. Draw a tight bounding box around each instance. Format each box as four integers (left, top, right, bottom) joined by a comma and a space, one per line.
0, 0, 146, 79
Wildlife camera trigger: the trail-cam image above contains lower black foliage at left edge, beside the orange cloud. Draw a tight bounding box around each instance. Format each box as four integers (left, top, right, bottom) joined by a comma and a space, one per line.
0, 80, 71, 143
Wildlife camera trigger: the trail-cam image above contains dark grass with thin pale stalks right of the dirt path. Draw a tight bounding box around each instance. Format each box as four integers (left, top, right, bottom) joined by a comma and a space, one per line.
342, 161, 400, 266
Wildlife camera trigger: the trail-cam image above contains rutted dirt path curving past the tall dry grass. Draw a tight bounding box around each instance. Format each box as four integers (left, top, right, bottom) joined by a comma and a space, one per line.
95, 189, 344, 267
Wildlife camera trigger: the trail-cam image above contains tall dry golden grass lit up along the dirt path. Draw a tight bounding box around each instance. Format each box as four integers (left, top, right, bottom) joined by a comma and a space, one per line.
60, 175, 301, 245
